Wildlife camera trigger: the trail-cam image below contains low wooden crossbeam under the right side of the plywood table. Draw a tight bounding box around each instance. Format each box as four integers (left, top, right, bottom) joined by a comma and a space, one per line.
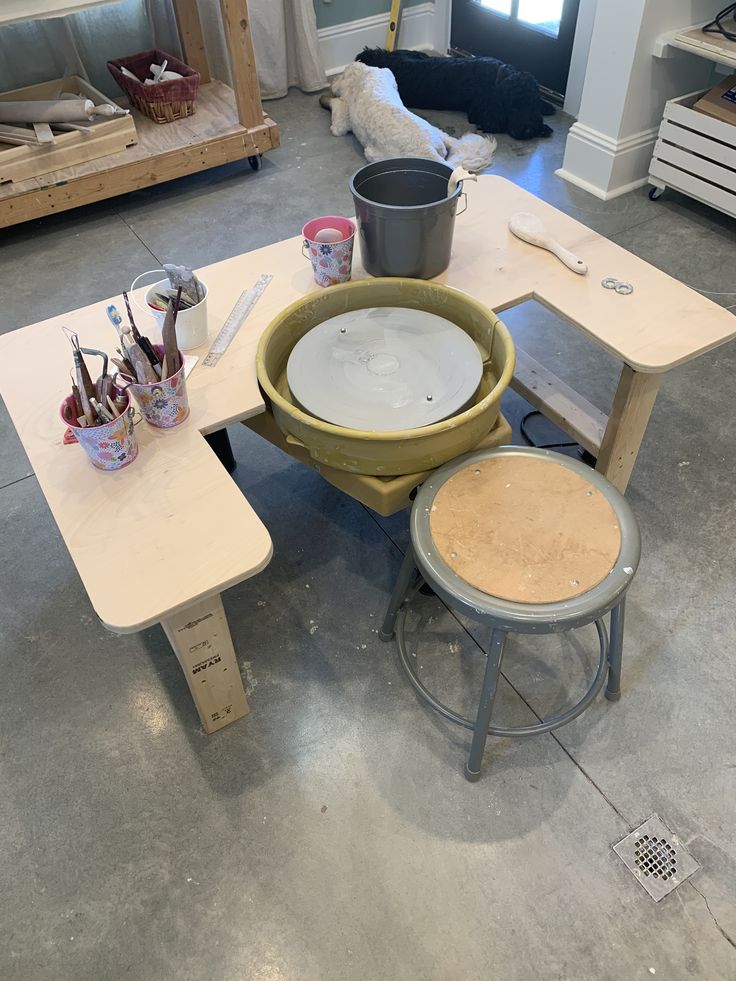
511, 347, 608, 456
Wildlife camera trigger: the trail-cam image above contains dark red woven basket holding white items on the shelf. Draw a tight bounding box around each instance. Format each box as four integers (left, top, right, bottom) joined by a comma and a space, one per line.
107, 48, 199, 123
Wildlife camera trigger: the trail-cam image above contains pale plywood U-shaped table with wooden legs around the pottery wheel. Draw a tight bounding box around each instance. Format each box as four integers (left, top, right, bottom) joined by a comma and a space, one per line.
0, 177, 736, 732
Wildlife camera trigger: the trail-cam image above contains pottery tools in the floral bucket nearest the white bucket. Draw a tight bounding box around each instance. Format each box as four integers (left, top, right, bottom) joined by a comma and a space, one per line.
107, 286, 183, 385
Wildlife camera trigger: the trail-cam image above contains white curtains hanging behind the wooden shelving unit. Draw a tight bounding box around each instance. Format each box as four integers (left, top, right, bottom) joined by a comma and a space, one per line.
0, 0, 327, 99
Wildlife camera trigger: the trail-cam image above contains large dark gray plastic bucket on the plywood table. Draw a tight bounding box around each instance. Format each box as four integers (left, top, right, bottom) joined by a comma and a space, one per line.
350, 157, 462, 279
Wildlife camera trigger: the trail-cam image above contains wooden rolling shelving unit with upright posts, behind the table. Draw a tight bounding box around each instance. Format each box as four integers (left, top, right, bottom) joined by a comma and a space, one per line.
0, 0, 279, 228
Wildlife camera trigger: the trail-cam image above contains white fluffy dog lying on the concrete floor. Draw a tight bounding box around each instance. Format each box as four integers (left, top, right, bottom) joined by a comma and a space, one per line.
320, 61, 496, 172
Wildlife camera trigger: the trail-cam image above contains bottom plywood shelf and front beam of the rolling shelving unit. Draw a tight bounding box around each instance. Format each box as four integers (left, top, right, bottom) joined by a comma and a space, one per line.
0, 82, 279, 228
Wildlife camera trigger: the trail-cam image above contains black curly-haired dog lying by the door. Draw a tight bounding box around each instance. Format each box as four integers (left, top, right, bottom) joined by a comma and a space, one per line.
355, 48, 555, 140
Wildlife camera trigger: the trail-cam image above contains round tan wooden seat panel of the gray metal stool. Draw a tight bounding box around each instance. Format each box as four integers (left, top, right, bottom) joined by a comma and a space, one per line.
429, 455, 621, 603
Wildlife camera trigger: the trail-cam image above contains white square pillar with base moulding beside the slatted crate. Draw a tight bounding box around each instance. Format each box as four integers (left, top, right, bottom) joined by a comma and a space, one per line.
558, 0, 718, 198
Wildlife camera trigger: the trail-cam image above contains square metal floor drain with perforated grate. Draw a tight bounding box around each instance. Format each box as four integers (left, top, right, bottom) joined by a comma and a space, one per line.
613, 814, 700, 903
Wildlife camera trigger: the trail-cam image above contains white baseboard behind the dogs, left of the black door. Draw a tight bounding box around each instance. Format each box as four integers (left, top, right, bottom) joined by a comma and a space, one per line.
317, 3, 437, 76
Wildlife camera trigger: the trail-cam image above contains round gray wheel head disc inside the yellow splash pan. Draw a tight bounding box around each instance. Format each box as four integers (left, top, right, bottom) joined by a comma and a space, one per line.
286, 307, 483, 432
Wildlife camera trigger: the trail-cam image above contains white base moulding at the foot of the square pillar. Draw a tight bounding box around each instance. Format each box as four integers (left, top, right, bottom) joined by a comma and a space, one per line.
556, 122, 659, 201
